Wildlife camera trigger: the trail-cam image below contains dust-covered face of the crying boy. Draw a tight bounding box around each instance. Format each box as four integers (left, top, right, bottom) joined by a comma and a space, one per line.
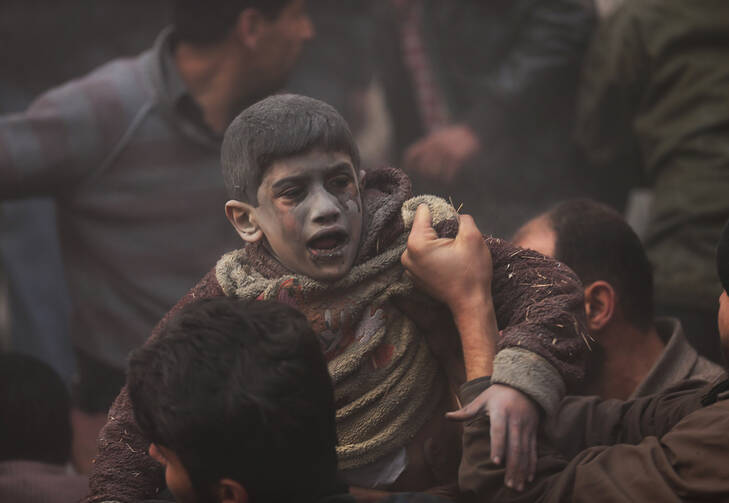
253, 150, 363, 281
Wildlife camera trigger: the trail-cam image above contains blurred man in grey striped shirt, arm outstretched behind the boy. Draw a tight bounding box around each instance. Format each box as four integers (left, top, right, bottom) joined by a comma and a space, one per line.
0, 0, 314, 471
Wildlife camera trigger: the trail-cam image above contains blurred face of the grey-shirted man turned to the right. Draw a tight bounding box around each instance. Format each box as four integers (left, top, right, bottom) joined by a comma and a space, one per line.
258, 0, 314, 89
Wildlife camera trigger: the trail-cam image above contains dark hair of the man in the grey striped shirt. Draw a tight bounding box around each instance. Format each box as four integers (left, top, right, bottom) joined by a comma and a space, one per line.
172, 0, 292, 46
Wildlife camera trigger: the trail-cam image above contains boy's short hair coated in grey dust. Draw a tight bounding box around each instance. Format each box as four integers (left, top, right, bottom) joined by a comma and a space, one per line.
221, 94, 359, 205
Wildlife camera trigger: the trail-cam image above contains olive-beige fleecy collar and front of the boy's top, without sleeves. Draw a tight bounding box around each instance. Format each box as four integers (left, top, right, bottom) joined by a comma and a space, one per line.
216, 174, 456, 470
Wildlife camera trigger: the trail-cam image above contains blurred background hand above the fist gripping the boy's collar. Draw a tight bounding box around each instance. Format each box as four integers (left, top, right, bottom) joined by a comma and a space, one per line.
403, 125, 480, 182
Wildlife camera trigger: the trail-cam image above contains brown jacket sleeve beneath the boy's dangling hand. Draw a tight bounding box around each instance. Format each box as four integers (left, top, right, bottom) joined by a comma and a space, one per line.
459, 376, 729, 502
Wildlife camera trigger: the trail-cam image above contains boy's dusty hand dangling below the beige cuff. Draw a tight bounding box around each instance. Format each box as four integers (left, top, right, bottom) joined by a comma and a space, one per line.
446, 384, 539, 491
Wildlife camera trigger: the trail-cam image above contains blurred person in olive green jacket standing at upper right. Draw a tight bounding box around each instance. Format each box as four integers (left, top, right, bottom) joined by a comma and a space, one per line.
576, 0, 729, 362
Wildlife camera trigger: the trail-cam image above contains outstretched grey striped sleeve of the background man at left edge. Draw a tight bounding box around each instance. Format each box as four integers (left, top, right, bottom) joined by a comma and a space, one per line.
0, 83, 111, 200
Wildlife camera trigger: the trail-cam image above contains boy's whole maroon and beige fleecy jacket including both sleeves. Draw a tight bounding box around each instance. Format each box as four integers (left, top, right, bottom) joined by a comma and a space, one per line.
89, 168, 587, 502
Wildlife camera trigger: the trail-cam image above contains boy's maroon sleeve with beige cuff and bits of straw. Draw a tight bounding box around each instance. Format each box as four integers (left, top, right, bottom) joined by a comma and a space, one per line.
487, 238, 589, 415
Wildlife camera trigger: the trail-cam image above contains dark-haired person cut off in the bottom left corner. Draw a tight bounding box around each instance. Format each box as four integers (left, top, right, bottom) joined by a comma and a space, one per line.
0, 353, 88, 503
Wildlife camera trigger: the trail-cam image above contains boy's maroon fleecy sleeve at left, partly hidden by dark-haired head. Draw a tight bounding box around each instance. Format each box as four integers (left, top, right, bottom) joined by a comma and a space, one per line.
84, 269, 224, 503
